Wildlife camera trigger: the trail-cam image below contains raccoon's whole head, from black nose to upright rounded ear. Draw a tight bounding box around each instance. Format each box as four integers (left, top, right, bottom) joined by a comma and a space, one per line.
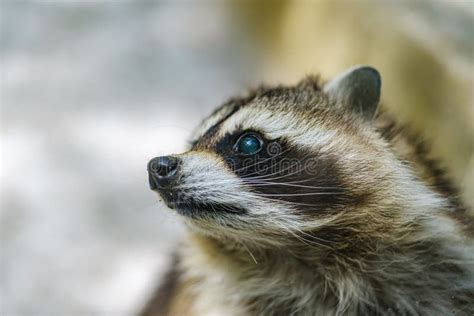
148, 67, 387, 238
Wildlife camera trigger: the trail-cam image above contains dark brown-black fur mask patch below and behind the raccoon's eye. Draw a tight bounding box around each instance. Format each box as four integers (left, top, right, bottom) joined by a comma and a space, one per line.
215, 134, 359, 215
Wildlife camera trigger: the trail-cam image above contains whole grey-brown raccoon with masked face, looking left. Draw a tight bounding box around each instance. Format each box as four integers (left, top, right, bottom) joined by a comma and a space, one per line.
141, 66, 474, 316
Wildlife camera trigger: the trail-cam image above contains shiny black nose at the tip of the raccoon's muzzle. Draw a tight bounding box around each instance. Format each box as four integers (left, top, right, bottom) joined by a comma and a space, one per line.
148, 156, 179, 190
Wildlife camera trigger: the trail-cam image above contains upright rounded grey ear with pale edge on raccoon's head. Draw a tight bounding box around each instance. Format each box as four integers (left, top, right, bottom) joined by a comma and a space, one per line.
324, 66, 382, 120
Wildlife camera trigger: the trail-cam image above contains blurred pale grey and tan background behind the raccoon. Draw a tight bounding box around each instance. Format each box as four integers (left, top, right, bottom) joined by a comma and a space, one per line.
0, 0, 474, 316
